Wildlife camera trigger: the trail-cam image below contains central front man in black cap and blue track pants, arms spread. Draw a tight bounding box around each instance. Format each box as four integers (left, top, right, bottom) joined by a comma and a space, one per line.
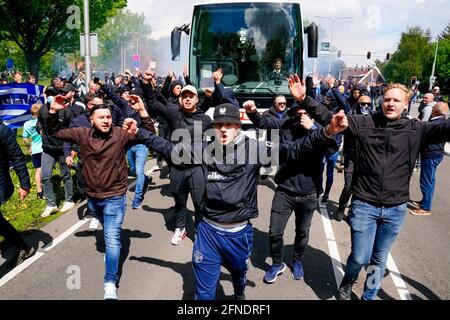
124, 103, 346, 300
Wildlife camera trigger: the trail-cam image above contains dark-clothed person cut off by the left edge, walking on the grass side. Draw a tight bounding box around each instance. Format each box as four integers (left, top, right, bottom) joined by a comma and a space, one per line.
0, 119, 35, 267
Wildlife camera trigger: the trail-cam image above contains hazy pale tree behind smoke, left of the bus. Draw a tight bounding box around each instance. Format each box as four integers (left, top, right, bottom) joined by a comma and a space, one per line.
95, 10, 151, 72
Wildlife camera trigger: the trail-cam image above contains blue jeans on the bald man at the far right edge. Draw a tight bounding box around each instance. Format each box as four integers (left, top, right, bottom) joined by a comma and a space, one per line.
420, 156, 444, 211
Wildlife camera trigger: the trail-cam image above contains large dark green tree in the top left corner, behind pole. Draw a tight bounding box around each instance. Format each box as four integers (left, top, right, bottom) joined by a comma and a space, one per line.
0, 0, 127, 77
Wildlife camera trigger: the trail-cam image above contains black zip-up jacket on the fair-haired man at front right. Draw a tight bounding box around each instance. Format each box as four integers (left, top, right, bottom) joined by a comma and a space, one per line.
307, 99, 450, 206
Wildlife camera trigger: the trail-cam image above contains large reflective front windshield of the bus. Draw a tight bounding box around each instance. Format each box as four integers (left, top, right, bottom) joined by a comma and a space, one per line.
190, 2, 303, 95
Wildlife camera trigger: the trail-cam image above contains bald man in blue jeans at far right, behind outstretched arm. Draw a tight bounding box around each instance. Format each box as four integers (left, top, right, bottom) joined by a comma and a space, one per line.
409, 102, 448, 216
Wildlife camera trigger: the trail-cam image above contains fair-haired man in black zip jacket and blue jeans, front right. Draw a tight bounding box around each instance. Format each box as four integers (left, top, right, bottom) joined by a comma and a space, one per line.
292, 79, 450, 300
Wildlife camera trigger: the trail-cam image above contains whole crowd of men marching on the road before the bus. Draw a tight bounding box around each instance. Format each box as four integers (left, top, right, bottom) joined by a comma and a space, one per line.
0, 69, 450, 300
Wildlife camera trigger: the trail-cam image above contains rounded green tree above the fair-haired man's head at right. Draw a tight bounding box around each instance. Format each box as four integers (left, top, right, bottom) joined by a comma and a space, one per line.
382, 27, 433, 84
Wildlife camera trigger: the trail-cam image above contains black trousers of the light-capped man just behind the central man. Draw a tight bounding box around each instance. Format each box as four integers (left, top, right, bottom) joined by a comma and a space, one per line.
170, 166, 205, 229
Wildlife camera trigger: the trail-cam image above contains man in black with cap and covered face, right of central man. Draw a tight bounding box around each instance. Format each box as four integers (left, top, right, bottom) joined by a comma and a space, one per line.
244, 77, 338, 283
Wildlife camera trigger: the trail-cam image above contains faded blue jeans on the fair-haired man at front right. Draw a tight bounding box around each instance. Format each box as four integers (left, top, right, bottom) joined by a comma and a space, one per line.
345, 199, 407, 300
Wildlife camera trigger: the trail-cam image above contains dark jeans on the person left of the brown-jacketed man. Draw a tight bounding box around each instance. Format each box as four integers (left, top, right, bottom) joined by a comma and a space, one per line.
41, 151, 73, 207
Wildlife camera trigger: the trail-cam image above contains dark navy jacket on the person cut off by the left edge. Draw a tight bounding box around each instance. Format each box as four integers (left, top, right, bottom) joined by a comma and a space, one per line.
0, 119, 31, 204
